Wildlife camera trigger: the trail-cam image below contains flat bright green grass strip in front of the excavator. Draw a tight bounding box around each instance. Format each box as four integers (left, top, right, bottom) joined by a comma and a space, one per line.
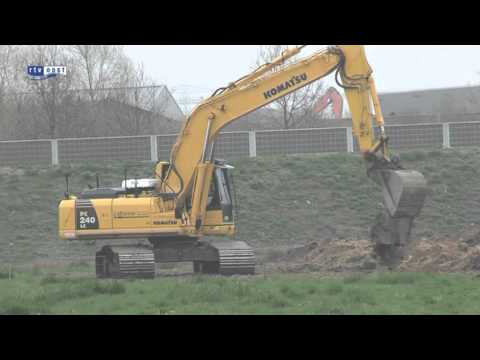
0, 272, 480, 315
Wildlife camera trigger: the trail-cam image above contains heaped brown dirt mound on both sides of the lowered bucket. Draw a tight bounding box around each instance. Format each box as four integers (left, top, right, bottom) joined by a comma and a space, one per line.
270, 225, 480, 272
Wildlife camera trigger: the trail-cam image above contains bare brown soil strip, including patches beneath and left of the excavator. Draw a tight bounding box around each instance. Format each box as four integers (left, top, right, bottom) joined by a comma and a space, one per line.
22, 225, 480, 276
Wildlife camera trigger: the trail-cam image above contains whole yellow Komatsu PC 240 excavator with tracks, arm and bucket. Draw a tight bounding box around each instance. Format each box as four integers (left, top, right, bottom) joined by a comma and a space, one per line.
59, 45, 427, 278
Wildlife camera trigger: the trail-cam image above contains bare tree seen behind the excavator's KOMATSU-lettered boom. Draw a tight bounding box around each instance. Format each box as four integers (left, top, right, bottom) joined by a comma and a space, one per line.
257, 45, 323, 129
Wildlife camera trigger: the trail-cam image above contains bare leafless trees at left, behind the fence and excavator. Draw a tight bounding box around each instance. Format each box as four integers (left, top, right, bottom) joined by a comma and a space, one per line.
0, 45, 178, 140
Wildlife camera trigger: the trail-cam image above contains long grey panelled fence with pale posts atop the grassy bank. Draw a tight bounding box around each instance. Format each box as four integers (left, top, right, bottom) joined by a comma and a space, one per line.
0, 121, 480, 166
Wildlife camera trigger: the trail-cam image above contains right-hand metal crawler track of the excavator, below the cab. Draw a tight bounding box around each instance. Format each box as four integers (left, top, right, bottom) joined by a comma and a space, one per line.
194, 241, 256, 276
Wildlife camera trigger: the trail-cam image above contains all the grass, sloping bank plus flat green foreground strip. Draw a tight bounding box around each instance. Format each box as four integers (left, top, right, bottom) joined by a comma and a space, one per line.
0, 149, 480, 314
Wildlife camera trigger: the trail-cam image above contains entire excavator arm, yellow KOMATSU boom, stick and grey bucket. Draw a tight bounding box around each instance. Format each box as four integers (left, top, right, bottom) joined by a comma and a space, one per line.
157, 45, 426, 264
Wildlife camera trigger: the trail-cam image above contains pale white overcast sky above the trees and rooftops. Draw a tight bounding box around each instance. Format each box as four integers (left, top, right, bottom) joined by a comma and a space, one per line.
125, 45, 480, 105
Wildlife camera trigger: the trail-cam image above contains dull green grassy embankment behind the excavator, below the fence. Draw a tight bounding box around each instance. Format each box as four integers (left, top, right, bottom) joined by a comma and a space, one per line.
0, 148, 480, 265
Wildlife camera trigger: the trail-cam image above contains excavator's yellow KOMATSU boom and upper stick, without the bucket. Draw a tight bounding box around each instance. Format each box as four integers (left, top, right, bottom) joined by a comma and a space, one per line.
164, 45, 383, 200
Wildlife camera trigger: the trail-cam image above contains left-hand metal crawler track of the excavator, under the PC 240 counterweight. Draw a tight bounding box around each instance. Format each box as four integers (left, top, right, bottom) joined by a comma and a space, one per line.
95, 246, 155, 279
